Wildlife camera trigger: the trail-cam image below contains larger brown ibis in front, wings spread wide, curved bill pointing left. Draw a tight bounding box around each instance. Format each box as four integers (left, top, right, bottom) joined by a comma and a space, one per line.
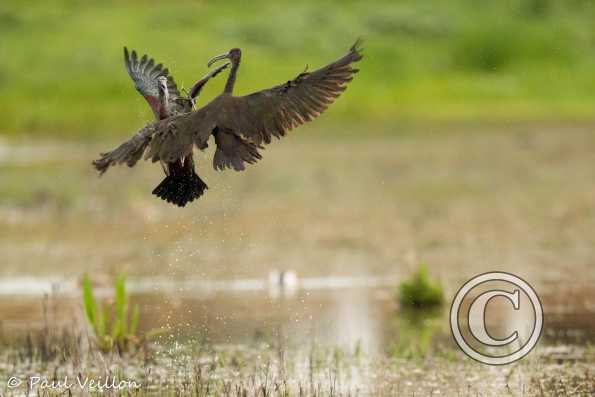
93, 40, 362, 206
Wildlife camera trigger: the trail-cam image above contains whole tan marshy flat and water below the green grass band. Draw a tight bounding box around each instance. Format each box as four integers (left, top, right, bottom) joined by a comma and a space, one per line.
0, 131, 595, 397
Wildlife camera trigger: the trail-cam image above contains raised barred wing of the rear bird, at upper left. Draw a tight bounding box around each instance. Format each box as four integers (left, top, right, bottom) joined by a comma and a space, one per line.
124, 47, 180, 119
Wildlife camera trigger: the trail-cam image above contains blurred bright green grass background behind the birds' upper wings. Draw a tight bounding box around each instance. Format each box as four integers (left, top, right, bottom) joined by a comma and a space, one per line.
0, 0, 595, 139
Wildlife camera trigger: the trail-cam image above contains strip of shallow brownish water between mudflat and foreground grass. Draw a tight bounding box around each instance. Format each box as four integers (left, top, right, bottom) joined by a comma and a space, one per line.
0, 273, 595, 356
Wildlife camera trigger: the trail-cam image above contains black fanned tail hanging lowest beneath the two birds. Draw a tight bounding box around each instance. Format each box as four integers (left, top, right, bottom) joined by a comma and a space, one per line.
153, 159, 209, 207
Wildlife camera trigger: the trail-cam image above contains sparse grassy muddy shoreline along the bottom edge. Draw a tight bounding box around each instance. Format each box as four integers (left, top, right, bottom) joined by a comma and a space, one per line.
0, 316, 595, 397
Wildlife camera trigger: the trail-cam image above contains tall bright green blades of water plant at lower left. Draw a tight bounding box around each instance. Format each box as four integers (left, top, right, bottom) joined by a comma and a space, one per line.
83, 274, 141, 353
